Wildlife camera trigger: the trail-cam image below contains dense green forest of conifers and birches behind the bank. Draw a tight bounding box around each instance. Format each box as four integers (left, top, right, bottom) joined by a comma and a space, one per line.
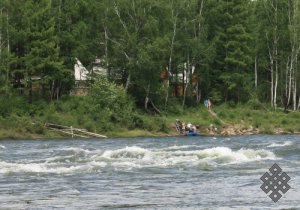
0, 0, 300, 138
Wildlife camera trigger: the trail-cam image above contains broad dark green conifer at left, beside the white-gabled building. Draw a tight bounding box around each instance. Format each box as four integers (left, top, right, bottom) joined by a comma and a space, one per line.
12, 0, 64, 102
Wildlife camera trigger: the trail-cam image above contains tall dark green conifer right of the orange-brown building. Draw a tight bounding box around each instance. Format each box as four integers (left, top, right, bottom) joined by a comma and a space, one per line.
220, 0, 252, 102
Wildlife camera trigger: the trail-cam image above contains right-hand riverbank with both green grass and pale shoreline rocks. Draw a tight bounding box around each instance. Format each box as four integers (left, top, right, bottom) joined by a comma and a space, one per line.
166, 104, 300, 136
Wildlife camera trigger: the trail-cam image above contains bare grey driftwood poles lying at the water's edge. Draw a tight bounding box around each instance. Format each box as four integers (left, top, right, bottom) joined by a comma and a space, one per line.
45, 123, 107, 138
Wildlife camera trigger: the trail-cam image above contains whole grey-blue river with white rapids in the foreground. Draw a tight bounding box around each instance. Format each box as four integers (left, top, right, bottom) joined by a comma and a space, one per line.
0, 135, 300, 209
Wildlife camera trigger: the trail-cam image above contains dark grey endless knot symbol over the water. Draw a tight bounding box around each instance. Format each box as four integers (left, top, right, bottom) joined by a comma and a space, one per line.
260, 163, 291, 203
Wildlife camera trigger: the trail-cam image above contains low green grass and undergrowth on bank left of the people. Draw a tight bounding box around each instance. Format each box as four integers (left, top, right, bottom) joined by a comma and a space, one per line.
0, 97, 169, 139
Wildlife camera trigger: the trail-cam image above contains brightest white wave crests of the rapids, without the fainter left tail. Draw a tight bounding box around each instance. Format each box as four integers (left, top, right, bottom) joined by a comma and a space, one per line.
97, 147, 276, 167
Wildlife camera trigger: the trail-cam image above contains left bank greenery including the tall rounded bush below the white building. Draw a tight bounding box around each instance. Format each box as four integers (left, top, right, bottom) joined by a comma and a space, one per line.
0, 77, 168, 138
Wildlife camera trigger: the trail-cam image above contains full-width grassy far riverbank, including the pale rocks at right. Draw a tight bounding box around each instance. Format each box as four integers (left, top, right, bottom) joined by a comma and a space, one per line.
0, 105, 300, 139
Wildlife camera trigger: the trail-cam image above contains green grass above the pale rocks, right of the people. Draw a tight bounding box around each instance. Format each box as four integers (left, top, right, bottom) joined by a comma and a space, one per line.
166, 104, 300, 134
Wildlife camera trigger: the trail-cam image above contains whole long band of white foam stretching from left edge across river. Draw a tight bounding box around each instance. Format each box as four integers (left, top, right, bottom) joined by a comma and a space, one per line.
0, 145, 276, 174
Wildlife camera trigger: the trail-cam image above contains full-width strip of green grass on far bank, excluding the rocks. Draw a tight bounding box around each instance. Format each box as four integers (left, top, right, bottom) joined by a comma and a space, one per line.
0, 97, 300, 139
